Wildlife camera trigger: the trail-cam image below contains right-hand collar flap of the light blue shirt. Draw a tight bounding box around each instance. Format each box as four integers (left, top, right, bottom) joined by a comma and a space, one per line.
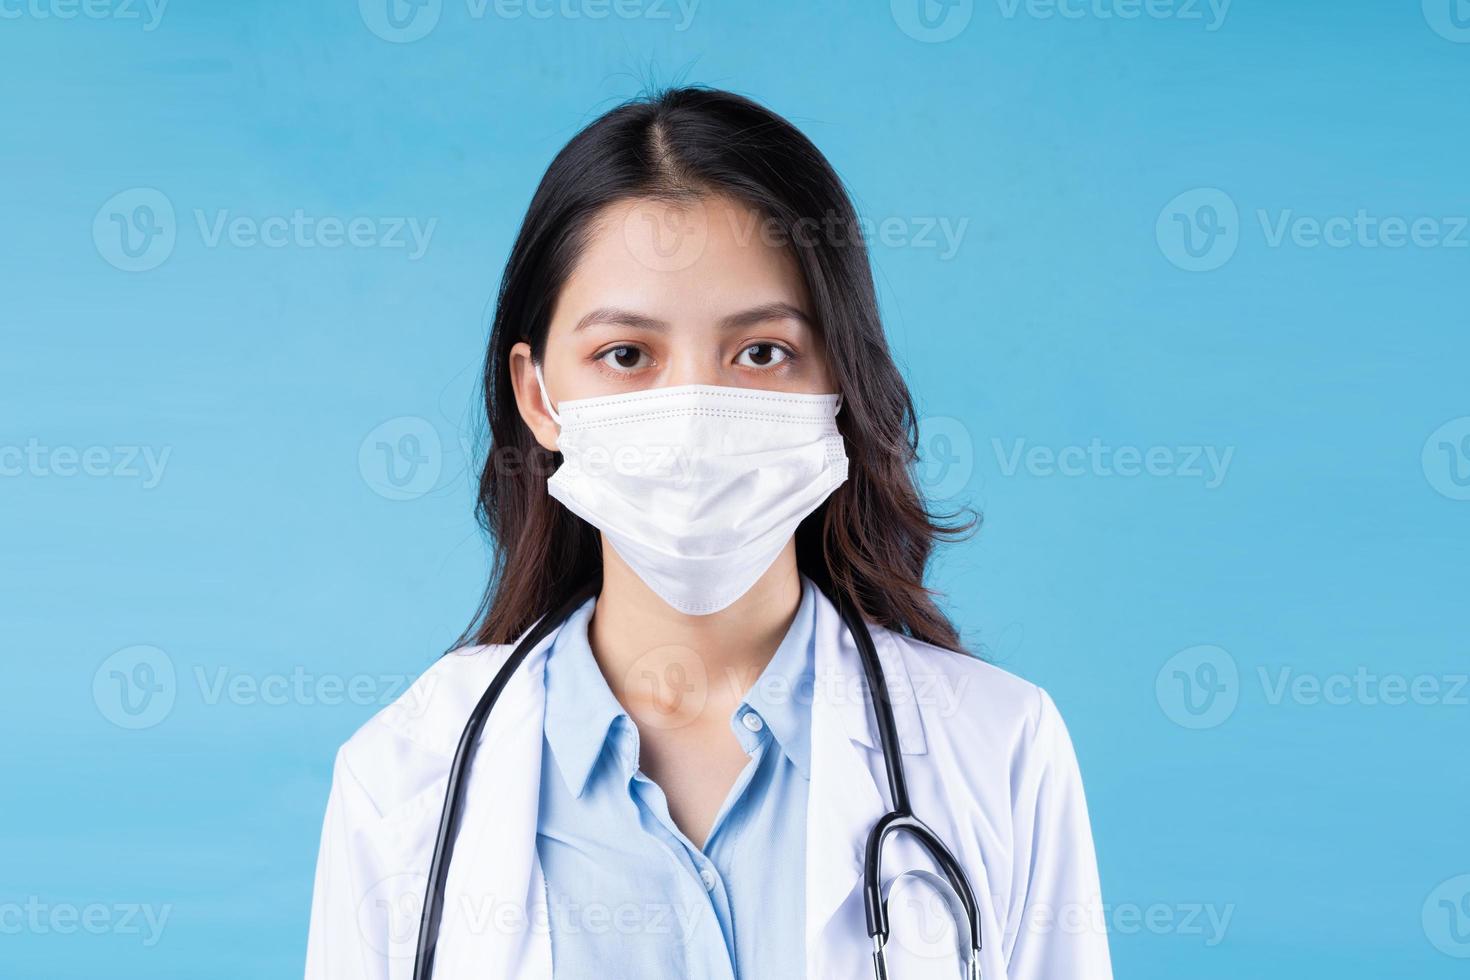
734, 576, 816, 779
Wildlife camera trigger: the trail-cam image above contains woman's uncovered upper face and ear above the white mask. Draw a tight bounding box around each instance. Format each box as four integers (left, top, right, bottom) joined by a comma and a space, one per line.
510, 197, 835, 451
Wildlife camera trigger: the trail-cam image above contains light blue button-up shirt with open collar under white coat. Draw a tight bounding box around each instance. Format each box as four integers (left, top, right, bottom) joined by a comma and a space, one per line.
537, 579, 814, 980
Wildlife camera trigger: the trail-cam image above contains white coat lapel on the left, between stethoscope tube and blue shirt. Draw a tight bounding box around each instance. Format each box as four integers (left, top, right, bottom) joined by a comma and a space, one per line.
435, 633, 554, 980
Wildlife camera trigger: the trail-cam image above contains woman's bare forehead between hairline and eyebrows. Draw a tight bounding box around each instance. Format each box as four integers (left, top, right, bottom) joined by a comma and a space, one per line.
556, 195, 807, 319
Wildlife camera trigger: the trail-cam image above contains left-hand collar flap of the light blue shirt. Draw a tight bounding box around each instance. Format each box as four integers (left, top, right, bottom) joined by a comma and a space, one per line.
545, 597, 628, 796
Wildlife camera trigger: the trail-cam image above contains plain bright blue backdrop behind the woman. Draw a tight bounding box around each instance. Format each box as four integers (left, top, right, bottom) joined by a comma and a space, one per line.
0, 0, 1470, 980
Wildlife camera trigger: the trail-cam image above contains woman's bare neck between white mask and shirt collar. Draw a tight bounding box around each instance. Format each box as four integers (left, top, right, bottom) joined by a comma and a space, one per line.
588, 539, 801, 716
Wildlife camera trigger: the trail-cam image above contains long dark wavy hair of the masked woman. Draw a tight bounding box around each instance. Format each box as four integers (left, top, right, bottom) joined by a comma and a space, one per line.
462, 88, 973, 649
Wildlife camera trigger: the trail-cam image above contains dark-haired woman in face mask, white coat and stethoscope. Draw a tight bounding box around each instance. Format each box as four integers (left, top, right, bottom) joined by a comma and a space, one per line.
307, 88, 1111, 980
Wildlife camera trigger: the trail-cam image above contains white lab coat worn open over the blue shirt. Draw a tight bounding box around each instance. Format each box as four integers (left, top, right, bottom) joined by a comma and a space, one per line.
306, 592, 1113, 980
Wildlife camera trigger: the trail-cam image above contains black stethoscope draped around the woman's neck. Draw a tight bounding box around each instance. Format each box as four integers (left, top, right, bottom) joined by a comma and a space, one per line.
413, 583, 980, 980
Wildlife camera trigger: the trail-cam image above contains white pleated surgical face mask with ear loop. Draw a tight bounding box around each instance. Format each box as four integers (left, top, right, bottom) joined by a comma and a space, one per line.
537, 364, 847, 616
